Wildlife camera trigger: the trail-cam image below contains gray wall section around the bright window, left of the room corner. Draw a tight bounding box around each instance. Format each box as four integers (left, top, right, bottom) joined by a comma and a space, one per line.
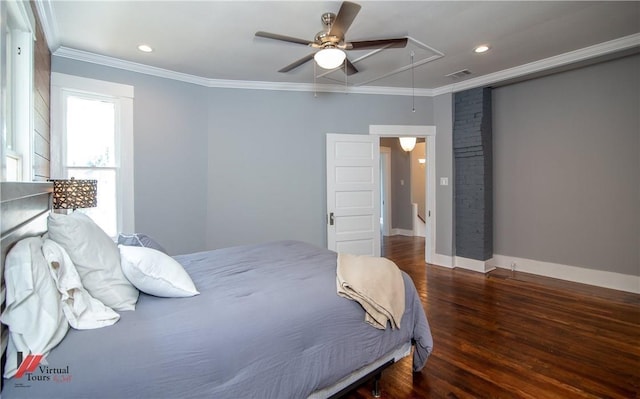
51, 56, 208, 254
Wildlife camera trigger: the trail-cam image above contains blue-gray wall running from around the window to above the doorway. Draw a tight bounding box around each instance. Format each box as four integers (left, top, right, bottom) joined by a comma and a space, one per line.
52, 56, 434, 254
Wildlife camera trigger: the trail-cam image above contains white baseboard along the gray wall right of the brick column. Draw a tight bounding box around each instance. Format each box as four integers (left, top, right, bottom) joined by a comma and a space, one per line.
491, 255, 640, 294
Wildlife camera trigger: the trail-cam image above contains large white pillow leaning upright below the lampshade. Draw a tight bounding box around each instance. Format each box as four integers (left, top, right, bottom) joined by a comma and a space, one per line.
48, 212, 138, 310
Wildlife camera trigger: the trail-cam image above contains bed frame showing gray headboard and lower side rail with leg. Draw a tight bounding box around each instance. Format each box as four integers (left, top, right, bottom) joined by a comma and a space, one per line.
0, 182, 400, 398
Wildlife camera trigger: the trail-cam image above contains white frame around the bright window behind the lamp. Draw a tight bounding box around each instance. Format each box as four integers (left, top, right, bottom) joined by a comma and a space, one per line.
51, 72, 135, 232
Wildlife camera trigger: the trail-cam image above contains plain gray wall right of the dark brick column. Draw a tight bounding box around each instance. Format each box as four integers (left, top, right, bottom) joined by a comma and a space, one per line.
493, 56, 640, 275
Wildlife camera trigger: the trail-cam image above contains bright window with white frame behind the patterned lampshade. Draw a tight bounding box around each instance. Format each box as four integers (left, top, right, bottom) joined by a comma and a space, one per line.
51, 73, 134, 237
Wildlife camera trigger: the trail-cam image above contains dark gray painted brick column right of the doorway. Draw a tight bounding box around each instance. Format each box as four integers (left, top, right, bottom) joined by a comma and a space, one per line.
453, 88, 493, 262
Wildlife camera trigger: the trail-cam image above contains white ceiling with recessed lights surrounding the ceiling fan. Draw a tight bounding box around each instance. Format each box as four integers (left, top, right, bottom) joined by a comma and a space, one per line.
36, 0, 640, 91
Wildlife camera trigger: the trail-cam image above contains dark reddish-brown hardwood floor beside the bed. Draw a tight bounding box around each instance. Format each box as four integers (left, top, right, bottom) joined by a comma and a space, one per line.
347, 236, 640, 399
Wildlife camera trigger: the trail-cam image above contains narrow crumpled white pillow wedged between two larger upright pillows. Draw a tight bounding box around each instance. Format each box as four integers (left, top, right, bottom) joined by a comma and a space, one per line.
42, 240, 120, 330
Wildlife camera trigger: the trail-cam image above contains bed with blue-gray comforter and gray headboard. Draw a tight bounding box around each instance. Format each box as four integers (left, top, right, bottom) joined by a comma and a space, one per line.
2, 183, 432, 399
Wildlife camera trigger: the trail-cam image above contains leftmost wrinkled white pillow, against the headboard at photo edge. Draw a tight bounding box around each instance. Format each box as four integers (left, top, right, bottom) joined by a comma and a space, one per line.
0, 237, 69, 378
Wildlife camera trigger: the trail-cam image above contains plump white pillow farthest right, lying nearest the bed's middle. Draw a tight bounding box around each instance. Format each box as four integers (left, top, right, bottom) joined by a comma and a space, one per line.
118, 245, 199, 297
